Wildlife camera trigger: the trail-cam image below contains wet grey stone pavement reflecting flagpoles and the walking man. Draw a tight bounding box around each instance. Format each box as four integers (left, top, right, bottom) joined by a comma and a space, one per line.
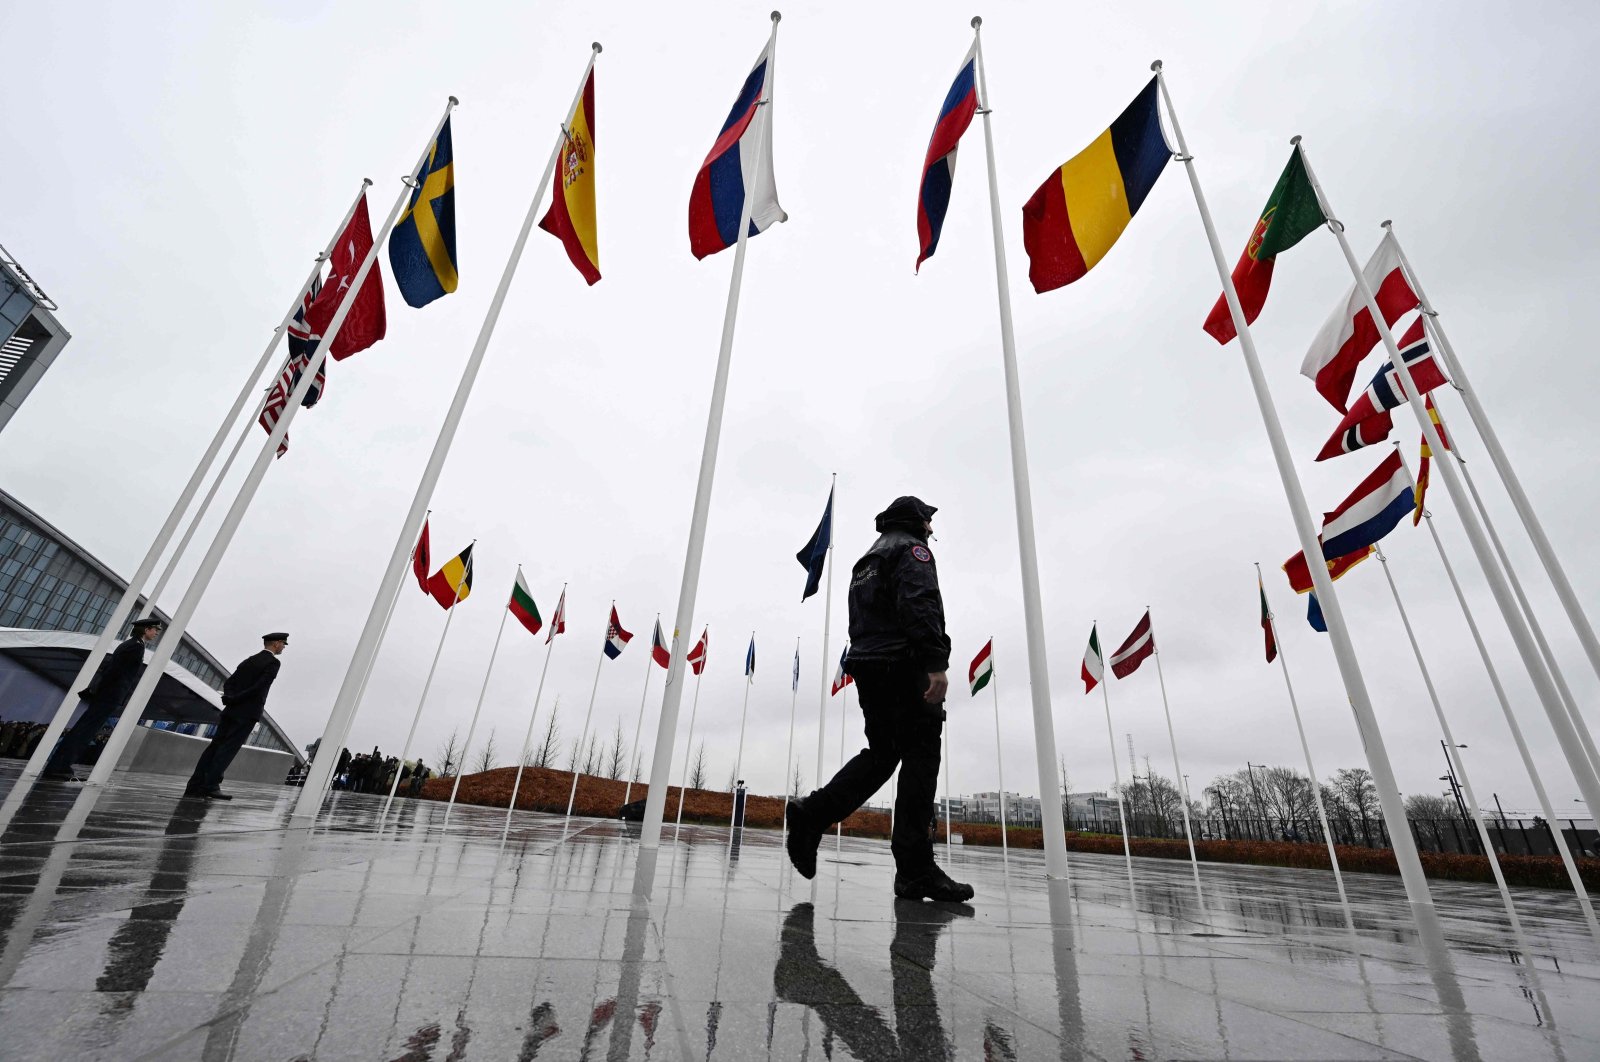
0, 768, 1600, 1062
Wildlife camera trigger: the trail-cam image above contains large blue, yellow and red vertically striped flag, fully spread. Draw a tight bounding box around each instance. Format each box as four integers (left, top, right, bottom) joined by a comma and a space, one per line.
1022, 77, 1173, 293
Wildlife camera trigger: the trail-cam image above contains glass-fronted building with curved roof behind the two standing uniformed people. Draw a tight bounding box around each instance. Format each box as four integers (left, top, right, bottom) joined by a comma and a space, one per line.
0, 491, 304, 782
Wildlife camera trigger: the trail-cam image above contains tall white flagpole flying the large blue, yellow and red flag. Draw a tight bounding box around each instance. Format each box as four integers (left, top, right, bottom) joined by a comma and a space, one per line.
1150, 59, 1442, 921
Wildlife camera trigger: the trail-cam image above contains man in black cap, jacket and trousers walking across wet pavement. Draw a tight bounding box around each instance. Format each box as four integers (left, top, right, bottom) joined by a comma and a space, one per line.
786, 496, 973, 904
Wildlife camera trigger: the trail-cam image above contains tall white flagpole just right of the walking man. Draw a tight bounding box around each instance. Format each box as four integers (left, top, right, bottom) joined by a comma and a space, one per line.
973, 18, 1067, 878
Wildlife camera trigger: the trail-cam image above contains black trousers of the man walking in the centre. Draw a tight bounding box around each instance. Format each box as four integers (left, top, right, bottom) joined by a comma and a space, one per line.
803, 661, 944, 873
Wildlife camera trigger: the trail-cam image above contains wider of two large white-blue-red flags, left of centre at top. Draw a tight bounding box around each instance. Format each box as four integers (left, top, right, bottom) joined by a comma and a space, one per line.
690, 45, 789, 258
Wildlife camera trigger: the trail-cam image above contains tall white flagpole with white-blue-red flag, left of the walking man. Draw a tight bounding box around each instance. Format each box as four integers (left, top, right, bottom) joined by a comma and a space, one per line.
640, 11, 781, 851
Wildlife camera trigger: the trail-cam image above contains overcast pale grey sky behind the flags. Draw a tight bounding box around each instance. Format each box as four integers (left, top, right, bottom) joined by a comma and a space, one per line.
0, 2, 1600, 809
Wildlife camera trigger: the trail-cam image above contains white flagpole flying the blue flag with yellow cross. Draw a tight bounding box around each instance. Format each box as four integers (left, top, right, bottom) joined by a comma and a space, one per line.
88, 96, 456, 786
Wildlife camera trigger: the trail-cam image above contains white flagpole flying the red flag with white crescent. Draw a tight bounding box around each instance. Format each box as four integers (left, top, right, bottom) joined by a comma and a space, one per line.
18, 178, 371, 785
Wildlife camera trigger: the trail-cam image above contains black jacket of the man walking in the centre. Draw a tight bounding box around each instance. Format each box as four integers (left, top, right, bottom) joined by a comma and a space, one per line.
845, 528, 950, 673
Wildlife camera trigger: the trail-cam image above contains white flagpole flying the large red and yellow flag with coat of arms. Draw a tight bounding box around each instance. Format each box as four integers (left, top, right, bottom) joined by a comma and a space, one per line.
293, 43, 600, 819
